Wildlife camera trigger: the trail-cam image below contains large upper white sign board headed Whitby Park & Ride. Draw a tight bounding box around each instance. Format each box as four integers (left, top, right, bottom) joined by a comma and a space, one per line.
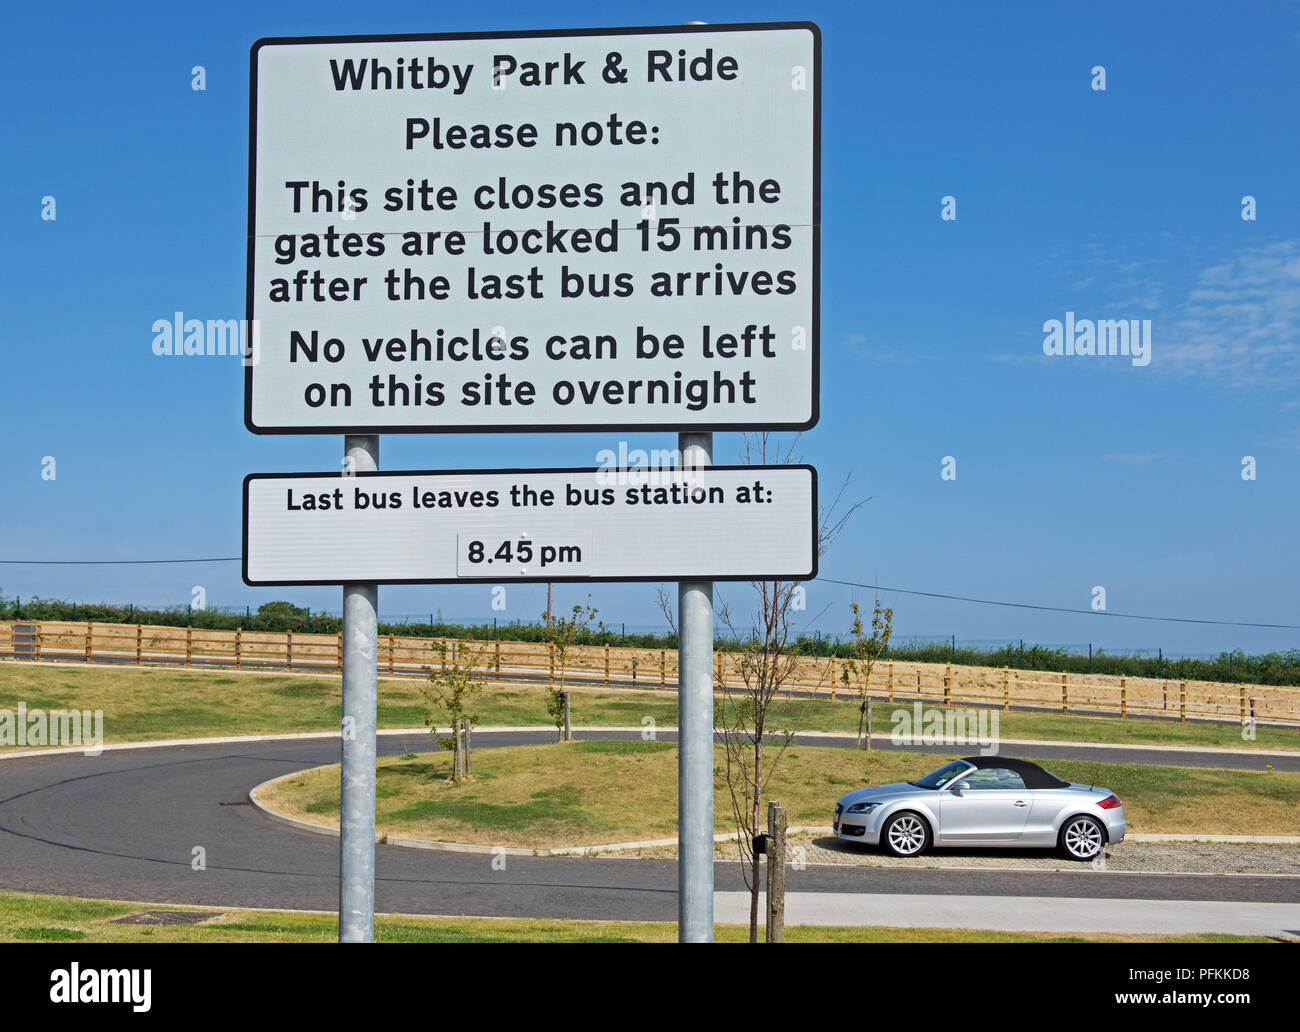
244, 22, 820, 434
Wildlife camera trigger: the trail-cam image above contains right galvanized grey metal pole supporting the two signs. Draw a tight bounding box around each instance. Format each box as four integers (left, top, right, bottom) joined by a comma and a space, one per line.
677, 433, 714, 942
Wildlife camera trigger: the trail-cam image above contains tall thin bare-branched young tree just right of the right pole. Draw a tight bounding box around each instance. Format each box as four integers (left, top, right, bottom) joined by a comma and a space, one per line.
659, 433, 870, 942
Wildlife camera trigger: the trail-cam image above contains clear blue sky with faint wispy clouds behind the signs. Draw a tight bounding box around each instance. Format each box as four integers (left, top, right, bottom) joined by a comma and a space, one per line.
0, 0, 1300, 652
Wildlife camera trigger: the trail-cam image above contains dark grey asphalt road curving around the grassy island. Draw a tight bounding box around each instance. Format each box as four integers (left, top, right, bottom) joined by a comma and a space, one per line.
0, 733, 1300, 920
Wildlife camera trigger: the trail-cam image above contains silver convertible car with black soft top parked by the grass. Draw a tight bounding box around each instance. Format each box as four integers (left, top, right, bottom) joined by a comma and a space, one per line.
835, 756, 1128, 860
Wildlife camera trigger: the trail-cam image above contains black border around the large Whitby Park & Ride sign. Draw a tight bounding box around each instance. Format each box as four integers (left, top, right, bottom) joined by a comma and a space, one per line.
244, 21, 822, 435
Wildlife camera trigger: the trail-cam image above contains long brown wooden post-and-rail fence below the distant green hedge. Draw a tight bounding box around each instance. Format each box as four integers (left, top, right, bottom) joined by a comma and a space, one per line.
0, 620, 1300, 725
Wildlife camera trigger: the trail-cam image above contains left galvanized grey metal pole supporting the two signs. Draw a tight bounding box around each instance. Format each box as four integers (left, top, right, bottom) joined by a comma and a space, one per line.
338, 434, 380, 942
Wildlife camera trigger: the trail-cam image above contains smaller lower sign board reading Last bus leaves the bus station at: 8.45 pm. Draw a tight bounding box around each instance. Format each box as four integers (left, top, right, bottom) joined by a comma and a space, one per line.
243, 465, 816, 586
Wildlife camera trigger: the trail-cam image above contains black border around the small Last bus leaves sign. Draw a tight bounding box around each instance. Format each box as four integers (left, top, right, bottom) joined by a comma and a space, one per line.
239, 463, 818, 587
